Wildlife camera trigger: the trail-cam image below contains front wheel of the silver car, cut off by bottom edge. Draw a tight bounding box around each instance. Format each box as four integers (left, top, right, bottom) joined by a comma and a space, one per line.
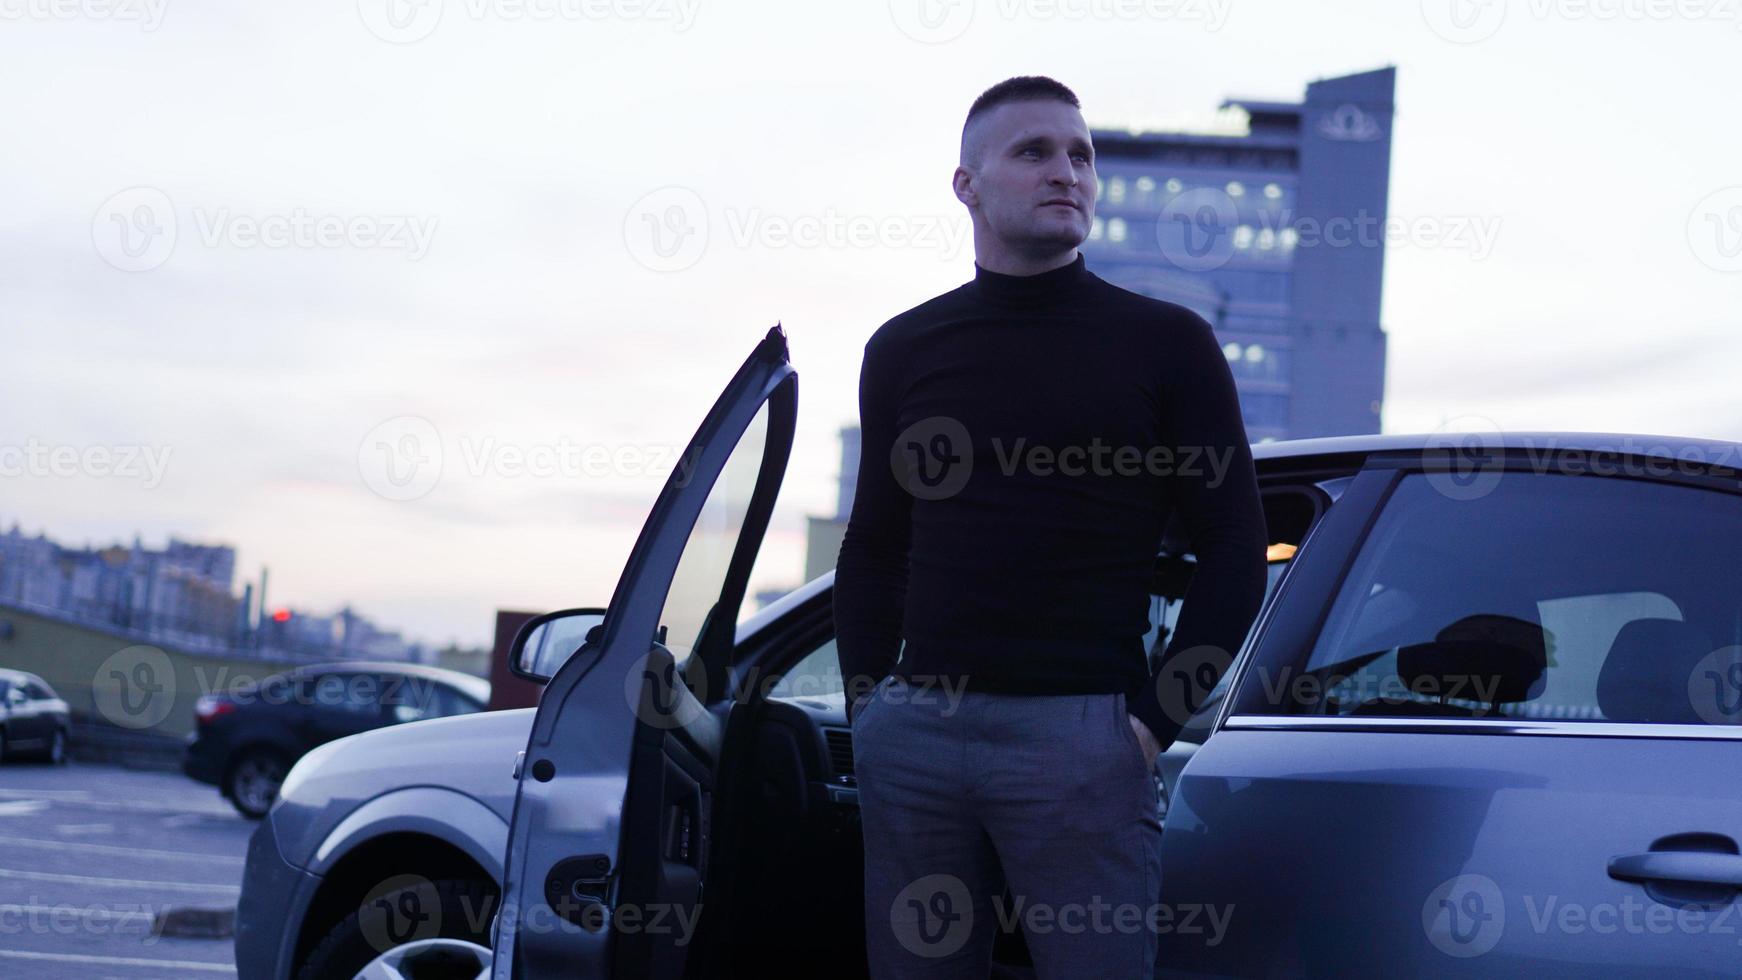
296, 874, 498, 980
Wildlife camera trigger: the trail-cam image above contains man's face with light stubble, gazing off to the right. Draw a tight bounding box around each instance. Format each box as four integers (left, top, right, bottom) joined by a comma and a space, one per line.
956, 99, 1096, 254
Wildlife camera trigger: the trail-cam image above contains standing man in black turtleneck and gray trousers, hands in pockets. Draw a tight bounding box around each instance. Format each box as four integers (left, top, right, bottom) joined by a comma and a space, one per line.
834, 77, 1265, 980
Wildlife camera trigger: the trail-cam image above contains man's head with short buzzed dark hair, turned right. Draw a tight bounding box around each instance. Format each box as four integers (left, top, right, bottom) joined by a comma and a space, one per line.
955, 75, 1096, 272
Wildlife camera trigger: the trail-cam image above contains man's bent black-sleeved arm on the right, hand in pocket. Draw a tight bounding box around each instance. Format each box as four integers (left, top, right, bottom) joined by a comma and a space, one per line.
1127, 317, 1268, 748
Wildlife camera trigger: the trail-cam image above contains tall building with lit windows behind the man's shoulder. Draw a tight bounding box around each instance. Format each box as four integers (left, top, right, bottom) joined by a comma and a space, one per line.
1082, 68, 1397, 442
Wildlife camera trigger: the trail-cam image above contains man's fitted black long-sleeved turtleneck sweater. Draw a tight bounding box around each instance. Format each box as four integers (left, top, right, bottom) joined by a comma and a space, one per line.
834, 252, 1265, 747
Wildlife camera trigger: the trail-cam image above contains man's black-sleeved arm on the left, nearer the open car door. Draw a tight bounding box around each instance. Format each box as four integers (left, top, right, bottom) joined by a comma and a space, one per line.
834, 331, 913, 724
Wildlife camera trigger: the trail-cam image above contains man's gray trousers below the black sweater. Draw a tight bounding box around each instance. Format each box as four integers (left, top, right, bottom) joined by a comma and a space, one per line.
854, 677, 1162, 980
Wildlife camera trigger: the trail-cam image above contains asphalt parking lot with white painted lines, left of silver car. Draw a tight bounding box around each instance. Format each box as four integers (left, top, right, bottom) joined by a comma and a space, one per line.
0, 762, 254, 980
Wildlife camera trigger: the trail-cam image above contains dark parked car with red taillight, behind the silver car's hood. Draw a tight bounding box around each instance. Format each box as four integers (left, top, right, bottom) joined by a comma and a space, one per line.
181, 661, 490, 820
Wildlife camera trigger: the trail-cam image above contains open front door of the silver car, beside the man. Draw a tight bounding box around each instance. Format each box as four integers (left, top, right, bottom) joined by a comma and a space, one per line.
491, 326, 798, 980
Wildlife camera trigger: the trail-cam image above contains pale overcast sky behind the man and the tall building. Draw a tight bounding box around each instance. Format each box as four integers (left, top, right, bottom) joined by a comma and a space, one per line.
0, 0, 1742, 644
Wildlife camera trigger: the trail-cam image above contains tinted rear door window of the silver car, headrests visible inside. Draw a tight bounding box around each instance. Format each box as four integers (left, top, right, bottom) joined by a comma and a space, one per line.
1282, 472, 1742, 724
